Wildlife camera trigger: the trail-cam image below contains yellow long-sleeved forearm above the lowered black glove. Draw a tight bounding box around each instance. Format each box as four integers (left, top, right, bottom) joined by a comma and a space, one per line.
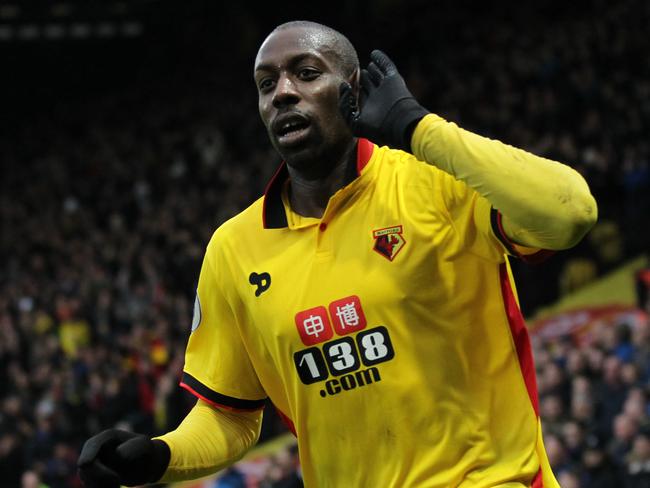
157, 400, 262, 482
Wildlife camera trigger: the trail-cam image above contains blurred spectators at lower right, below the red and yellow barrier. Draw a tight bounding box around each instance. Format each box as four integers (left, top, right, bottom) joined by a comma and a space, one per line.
533, 309, 650, 488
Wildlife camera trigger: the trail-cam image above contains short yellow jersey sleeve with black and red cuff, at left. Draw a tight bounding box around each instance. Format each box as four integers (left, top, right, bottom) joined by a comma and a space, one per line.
181, 239, 266, 411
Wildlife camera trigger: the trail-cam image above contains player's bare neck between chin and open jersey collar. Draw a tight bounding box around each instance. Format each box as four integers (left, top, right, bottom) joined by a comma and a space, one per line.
287, 142, 357, 218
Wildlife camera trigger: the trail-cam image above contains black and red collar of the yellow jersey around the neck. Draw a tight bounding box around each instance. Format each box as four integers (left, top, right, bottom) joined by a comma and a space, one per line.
262, 138, 374, 229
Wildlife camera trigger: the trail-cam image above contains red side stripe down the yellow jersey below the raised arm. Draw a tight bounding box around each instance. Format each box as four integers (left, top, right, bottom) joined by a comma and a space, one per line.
499, 263, 539, 417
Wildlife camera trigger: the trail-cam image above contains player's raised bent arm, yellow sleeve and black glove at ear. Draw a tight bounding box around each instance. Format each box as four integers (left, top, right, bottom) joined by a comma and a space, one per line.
340, 51, 597, 250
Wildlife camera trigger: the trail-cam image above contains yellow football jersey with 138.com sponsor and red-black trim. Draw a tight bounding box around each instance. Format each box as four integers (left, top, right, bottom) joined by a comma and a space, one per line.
182, 139, 557, 488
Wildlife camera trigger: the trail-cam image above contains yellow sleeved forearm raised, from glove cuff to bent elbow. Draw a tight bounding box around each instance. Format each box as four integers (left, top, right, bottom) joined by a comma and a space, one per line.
411, 114, 597, 250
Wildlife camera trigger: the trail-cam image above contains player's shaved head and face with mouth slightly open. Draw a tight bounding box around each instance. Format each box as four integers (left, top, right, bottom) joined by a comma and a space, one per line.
253, 20, 359, 175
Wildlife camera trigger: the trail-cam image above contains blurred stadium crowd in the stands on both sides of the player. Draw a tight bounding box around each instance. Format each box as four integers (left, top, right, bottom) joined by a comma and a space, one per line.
0, 0, 650, 488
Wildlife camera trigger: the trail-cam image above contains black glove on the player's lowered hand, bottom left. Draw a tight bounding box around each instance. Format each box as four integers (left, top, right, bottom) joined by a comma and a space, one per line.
77, 429, 171, 488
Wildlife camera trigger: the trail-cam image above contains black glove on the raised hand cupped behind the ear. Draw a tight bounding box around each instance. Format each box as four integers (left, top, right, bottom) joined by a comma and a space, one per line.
339, 49, 430, 152
